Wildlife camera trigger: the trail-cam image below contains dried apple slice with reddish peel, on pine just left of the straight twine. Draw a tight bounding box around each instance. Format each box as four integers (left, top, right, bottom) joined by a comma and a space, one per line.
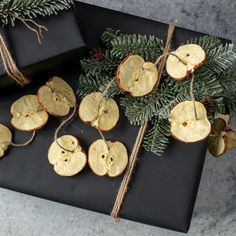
116, 55, 158, 97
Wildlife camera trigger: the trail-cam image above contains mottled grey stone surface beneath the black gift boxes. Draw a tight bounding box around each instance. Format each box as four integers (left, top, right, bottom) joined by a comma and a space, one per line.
0, 0, 236, 236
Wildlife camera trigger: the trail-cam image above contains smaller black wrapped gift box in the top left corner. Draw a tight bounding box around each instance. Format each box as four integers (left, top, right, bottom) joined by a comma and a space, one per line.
0, 7, 87, 92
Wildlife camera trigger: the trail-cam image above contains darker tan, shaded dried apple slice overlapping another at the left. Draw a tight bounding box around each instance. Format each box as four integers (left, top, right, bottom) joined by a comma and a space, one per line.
38, 76, 76, 116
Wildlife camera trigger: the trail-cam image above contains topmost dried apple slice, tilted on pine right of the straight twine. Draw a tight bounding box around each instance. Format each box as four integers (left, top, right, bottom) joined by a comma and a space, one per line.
166, 44, 206, 80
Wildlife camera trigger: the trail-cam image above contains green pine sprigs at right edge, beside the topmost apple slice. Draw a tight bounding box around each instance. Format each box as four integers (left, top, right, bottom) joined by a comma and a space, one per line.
178, 35, 236, 113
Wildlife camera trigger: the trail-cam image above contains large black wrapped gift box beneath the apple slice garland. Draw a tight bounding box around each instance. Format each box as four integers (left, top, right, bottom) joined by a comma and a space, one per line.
0, 2, 230, 232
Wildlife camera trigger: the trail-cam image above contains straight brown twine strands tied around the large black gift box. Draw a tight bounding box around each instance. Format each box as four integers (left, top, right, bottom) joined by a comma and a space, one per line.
111, 24, 175, 219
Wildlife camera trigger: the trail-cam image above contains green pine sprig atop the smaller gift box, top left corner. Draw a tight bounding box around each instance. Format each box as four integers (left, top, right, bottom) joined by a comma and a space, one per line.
0, 0, 73, 26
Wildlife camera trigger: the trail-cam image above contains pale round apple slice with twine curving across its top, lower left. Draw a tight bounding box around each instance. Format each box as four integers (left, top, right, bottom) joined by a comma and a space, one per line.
48, 135, 87, 177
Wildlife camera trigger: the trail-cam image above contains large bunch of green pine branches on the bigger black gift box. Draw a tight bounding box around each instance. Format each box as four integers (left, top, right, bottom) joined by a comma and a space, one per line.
77, 29, 236, 155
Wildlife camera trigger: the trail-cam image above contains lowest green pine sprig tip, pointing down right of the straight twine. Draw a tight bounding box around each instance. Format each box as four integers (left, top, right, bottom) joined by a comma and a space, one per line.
143, 118, 170, 156
